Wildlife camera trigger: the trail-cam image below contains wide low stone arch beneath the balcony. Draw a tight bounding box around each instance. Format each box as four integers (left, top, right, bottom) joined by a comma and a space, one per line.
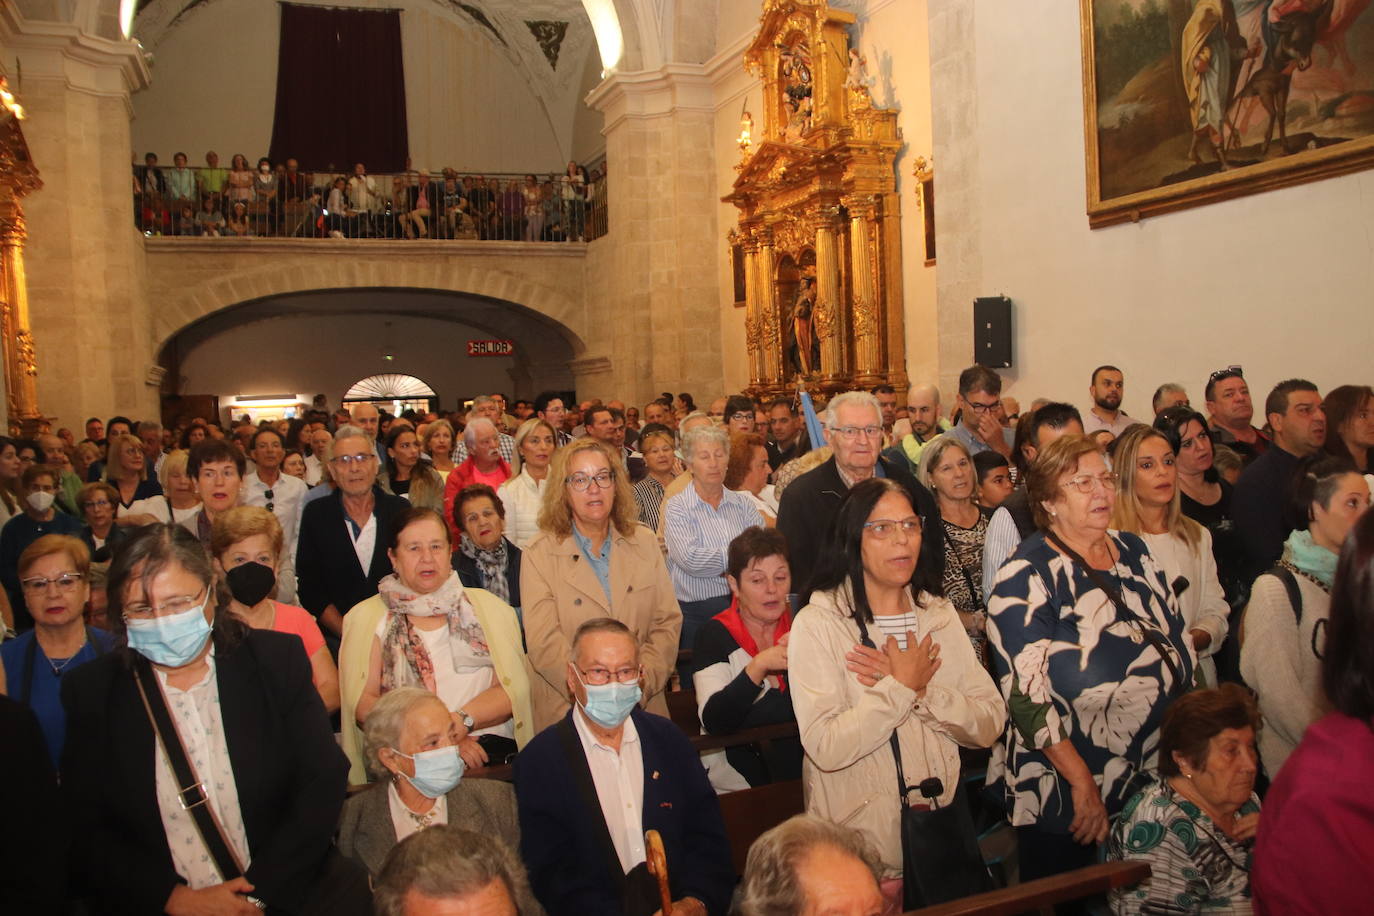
150, 249, 587, 358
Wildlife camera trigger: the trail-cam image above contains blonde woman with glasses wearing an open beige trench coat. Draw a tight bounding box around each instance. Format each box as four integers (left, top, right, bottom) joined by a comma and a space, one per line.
521, 438, 683, 732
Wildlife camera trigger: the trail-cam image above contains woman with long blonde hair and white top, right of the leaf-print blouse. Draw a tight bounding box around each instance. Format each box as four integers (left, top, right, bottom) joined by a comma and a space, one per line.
1110, 423, 1231, 687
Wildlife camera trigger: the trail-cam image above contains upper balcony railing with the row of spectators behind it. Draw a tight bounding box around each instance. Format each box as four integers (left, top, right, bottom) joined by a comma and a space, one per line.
133, 166, 606, 242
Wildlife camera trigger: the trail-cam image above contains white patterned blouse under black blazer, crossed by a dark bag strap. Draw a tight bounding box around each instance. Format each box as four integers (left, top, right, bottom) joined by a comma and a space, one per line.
153, 650, 251, 890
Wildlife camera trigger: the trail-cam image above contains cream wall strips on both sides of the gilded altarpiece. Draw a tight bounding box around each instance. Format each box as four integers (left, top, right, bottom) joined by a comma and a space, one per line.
708, 0, 938, 391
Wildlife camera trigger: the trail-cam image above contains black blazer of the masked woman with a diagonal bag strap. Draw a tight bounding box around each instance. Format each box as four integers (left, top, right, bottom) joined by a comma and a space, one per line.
62, 630, 348, 916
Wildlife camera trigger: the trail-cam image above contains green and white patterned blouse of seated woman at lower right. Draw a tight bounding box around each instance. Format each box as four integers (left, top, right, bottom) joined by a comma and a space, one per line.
1107, 780, 1260, 916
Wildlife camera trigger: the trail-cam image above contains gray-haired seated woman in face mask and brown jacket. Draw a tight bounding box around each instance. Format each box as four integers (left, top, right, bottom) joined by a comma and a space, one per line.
338, 687, 539, 912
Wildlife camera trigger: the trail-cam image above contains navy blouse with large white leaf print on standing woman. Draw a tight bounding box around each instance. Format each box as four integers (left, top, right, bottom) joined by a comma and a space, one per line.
988, 531, 1197, 834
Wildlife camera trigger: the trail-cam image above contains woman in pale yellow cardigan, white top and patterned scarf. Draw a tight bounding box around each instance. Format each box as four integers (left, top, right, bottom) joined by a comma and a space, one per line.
354, 508, 530, 766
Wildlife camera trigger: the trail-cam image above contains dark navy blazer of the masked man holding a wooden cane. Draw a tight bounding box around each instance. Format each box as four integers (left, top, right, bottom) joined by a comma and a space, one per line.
515, 709, 735, 916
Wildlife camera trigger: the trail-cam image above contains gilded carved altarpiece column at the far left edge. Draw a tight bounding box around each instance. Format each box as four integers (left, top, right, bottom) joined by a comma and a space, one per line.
0, 80, 44, 435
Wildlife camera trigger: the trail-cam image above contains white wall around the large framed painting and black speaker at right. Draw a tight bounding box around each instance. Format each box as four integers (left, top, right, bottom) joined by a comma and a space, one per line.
934, 0, 1374, 417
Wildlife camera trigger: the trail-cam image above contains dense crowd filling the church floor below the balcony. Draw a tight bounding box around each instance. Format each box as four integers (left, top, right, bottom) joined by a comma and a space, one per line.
0, 365, 1374, 916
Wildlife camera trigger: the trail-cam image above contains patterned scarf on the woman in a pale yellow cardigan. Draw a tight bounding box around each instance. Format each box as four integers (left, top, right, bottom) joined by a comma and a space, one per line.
376, 571, 491, 694
